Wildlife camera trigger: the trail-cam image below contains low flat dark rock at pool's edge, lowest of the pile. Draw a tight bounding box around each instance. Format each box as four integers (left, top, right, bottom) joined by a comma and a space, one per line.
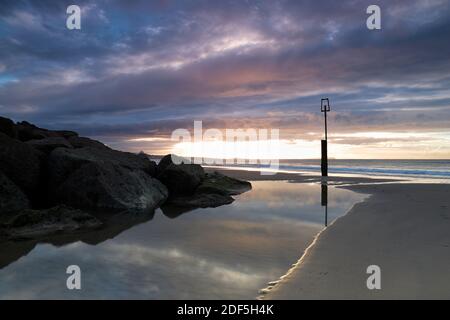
0, 206, 102, 240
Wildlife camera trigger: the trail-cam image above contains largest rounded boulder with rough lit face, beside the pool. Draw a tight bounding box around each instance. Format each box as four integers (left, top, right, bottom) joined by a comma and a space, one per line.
53, 162, 168, 210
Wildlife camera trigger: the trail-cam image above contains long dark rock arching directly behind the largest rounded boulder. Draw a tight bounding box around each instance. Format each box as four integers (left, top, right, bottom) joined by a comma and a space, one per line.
47, 147, 155, 187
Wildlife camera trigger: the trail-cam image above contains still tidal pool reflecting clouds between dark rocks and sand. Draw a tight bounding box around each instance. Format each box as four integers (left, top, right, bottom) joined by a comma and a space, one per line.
0, 181, 365, 299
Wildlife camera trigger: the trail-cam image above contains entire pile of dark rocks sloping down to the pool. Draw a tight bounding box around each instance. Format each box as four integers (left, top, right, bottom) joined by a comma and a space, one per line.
0, 118, 251, 245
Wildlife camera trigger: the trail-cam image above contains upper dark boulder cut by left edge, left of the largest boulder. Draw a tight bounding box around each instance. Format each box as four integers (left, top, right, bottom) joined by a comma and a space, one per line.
0, 133, 43, 193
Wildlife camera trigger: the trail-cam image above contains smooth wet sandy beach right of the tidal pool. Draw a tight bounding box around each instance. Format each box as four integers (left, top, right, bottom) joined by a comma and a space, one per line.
213, 170, 450, 299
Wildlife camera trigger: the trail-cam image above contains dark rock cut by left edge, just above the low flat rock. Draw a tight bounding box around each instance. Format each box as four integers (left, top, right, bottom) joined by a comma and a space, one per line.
0, 172, 30, 214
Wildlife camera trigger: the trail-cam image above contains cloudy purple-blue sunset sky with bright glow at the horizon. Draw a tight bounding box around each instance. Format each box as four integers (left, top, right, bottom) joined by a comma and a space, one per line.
0, 0, 450, 159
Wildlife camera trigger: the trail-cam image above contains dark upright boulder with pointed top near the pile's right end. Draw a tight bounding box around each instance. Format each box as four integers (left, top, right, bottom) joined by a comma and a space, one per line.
157, 154, 205, 197
